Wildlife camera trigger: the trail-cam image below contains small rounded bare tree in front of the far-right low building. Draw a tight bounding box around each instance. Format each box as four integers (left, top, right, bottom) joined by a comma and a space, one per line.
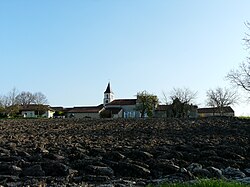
207, 87, 238, 114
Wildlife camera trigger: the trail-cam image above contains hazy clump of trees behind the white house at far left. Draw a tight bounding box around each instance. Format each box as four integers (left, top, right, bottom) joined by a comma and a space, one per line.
0, 88, 48, 116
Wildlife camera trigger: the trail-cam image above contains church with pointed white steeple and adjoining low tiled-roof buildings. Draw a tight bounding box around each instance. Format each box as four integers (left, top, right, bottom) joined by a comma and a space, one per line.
66, 83, 140, 119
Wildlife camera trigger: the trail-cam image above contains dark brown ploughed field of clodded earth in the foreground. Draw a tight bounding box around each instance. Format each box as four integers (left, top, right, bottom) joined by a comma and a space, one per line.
0, 118, 250, 186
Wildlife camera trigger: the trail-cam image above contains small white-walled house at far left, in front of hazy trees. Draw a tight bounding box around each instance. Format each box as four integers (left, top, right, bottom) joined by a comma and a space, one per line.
19, 104, 55, 118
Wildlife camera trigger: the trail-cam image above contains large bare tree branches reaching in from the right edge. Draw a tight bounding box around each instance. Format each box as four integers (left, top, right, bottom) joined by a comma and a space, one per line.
226, 22, 250, 95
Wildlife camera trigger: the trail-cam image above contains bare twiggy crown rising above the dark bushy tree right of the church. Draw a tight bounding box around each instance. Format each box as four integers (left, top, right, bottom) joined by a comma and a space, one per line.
170, 88, 197, 104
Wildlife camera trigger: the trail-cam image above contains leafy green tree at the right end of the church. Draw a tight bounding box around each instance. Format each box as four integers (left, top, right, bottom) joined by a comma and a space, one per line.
136, 91, 159, 118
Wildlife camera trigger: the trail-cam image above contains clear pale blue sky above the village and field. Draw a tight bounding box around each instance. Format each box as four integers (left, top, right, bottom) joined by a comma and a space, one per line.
0, 0, 250, 115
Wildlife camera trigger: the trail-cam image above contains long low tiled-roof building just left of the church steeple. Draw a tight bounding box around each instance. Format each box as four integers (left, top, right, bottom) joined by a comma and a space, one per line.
67, 104, 104, 119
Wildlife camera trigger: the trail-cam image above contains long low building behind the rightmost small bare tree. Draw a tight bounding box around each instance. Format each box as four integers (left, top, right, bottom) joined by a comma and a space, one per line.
197, 106, 234, 117
